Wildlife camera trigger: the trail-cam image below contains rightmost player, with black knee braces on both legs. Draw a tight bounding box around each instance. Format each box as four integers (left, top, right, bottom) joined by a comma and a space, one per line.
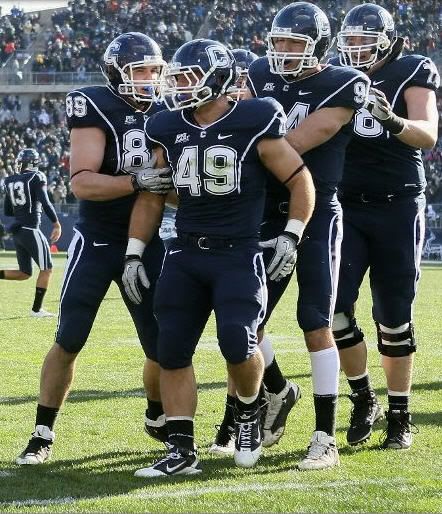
333, 4, 440, 449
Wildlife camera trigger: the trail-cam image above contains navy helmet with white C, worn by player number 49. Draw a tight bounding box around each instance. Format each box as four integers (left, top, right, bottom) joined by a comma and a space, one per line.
162, 39, 236, 111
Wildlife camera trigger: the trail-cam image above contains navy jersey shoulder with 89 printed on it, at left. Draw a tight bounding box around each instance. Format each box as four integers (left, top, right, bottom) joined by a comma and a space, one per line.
66, 86, 115, 130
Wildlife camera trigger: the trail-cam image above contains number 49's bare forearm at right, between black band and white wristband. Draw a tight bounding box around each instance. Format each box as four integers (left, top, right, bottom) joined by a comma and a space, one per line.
287, 167, 315, 225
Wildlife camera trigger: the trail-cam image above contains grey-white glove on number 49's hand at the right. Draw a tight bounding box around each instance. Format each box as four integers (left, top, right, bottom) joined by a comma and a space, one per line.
259, 232, 299, 282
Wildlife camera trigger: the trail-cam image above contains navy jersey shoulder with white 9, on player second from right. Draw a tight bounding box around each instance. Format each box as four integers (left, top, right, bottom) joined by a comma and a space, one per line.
317, 65, 370, 110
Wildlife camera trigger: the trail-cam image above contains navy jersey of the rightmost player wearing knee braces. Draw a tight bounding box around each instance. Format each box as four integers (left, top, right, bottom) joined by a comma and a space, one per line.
334, 55, 440, 194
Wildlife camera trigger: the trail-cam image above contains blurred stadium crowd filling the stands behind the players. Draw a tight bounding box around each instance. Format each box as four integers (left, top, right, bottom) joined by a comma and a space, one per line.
0, 0, 442, 203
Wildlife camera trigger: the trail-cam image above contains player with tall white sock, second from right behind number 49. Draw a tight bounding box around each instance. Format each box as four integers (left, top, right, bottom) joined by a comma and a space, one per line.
245, 2, 369, 469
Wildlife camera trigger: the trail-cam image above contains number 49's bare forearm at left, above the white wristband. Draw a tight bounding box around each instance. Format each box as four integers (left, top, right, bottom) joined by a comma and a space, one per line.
129, 192, 165, 244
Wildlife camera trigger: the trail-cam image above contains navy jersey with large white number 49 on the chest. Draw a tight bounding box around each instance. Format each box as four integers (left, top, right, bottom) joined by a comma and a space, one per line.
146, 98, 286, 238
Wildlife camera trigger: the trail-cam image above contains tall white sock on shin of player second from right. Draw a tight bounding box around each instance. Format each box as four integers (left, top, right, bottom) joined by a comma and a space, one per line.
310, 346, 340, 396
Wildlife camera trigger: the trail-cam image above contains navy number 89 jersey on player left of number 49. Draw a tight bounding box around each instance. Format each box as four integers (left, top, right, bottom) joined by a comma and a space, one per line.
66, 86, 163, 240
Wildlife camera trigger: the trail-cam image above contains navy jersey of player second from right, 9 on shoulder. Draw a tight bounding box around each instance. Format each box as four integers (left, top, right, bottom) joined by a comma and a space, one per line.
248, 57, 370, 201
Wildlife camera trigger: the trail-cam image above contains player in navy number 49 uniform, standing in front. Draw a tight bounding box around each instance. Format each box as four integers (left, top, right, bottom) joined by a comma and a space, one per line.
123, 39, 314, 477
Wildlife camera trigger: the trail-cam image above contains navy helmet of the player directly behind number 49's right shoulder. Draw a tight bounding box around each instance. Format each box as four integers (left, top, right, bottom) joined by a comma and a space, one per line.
267, 2, 331, 76
